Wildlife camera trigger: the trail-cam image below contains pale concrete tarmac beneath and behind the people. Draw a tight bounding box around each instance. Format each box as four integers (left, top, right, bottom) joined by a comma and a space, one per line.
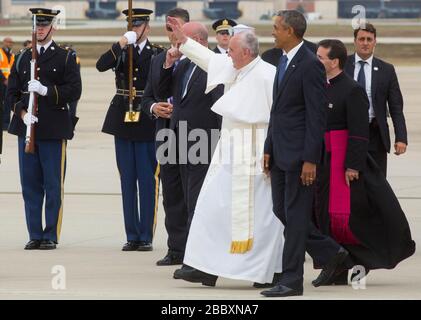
0, 67, 421, 300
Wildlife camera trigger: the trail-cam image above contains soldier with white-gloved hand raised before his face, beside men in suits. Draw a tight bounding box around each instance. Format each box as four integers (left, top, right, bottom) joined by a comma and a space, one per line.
96, 8, 162, 251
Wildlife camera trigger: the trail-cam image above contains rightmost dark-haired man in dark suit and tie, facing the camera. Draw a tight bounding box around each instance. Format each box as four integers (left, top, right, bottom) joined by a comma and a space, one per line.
345, 23, 408, 176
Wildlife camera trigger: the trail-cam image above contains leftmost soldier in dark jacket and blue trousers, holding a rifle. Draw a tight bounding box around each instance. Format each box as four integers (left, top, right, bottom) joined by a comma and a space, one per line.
6, 8, 82, 250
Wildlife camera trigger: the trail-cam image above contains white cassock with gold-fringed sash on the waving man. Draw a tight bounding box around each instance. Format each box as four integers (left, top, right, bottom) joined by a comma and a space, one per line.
180, 39, 283, 283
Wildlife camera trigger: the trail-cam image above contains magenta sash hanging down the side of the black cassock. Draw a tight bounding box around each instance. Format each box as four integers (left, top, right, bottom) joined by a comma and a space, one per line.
325, 130, 359, 244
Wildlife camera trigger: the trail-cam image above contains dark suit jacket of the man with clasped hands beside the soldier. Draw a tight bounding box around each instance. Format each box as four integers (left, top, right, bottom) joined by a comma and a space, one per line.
142, 51, 170, 147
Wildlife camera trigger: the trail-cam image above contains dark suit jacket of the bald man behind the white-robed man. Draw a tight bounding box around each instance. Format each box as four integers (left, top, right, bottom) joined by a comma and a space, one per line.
158, 59, 223, 130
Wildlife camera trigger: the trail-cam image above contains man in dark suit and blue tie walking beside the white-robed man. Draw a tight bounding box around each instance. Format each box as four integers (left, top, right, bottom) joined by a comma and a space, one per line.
262, 10, 348, 297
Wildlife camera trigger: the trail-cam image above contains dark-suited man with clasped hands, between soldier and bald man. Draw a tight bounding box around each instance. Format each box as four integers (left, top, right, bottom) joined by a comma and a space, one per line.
142, 8, 189, 266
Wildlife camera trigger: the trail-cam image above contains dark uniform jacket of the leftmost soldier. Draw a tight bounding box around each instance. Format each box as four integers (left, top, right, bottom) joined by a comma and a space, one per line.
6, 41, 82, 140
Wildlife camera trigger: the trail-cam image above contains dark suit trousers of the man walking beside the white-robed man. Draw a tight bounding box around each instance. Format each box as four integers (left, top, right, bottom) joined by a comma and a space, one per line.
271, 164, 340, 290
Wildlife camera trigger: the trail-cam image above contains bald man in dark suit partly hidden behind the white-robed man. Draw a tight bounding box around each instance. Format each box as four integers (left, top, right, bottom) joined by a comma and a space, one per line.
157, 22, 223, 268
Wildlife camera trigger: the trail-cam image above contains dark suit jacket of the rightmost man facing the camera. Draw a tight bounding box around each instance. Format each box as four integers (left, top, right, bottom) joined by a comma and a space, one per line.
345, 54, 408, 152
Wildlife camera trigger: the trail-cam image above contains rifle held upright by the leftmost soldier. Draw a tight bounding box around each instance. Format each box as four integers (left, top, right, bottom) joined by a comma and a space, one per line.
25, 14, 38, 153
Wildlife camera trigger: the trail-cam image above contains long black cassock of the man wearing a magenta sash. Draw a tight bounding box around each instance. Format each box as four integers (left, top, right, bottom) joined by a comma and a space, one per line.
315, 73, 415, 269
